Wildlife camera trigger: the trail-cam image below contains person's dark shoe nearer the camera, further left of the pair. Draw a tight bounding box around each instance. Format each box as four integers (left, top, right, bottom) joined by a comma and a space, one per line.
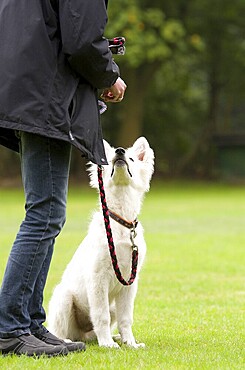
0, 334, 68, 357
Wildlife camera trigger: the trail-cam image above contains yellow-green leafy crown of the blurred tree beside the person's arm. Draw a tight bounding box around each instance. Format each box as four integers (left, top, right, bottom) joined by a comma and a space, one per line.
108, 0, 185, 68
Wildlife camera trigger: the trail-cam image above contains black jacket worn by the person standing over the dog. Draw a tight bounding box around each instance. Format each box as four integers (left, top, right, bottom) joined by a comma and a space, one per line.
0, 0, 119, 164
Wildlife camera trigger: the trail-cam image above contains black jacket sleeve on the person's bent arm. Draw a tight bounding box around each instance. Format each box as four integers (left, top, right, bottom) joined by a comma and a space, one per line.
59, 0, 119, 88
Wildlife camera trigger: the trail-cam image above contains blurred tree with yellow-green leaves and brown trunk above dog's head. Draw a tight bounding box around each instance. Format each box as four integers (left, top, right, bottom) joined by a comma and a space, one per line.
105, 0, 185, 145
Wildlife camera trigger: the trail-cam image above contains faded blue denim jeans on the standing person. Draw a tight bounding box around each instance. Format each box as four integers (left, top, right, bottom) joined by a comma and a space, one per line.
0, 132, 71, 338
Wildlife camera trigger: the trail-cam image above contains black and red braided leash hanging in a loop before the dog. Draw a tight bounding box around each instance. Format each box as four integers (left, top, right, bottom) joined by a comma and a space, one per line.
98, 166, 138, 285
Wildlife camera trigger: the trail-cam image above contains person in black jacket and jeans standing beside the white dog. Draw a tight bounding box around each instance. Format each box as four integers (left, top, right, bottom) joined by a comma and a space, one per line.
0, 0, 126, 356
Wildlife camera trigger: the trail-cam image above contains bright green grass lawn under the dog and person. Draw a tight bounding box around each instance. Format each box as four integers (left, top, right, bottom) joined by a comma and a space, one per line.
0, 182, 245, 370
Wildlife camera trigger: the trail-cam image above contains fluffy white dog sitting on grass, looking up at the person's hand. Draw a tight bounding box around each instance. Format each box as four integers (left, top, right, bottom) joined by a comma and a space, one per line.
48, 137, 154, 348
